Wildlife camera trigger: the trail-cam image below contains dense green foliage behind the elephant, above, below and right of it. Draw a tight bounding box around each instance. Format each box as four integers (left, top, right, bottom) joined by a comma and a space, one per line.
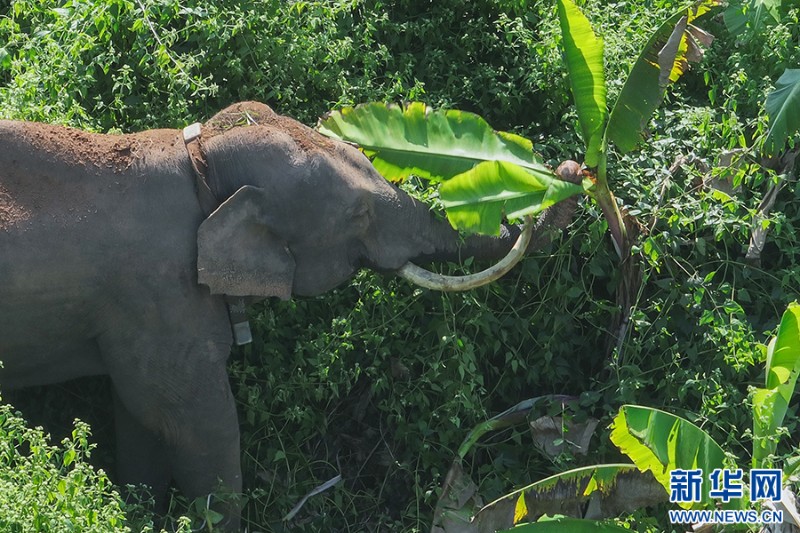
0, 0, 800, 531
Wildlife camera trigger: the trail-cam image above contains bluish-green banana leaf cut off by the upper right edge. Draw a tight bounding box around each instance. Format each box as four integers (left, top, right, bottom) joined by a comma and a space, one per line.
763, 69, 800, 155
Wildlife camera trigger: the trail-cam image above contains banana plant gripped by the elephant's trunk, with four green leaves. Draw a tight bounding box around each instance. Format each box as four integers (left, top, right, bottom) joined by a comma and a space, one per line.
317, 0, 721, 259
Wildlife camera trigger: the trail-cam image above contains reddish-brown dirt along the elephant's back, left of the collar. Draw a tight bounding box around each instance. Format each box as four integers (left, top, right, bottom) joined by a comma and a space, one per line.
13, 122, 175, 172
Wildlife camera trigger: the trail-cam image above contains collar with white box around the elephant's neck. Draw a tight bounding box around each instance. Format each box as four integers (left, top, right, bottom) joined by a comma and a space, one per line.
183, 122, 253, 346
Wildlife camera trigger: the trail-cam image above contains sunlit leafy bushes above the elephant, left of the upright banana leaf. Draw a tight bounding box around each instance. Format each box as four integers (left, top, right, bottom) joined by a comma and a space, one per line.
0, 0, 580, 130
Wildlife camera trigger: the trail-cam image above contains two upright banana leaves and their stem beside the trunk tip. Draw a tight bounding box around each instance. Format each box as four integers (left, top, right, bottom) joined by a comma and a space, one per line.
558, 0, 721, 259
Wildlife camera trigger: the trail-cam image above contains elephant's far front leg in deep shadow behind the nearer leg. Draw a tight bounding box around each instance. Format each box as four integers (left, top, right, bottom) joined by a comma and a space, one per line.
114, 391, 172, 514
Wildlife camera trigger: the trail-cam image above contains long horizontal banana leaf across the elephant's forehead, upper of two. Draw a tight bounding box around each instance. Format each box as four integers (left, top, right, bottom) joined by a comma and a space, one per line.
317, 102, 552, 181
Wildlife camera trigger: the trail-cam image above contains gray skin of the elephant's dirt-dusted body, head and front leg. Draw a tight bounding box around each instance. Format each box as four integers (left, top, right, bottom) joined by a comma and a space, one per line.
0, 103, 579, 529
